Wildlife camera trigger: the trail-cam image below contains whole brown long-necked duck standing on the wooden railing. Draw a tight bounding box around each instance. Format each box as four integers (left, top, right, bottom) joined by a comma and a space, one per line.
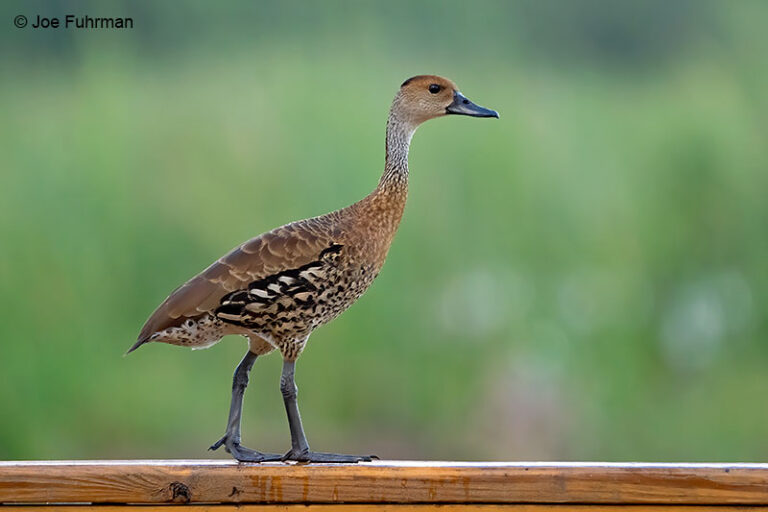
127, 75, 499, 463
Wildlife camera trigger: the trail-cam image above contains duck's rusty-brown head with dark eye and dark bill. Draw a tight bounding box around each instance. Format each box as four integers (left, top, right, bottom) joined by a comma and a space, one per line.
392, 75, 499, 125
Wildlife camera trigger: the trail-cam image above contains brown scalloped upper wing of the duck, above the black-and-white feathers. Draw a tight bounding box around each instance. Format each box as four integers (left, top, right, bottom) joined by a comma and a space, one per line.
131, 219, 333, 350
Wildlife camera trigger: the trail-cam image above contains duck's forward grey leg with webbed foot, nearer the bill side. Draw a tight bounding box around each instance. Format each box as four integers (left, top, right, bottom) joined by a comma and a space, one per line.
280, 360, 377, 462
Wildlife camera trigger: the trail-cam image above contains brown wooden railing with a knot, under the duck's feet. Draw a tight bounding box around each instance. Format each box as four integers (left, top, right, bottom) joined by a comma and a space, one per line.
0, 461, 768, 512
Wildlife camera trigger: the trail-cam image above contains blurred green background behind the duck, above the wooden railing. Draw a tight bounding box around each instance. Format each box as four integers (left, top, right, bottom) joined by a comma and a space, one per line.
0, 0, 768, 461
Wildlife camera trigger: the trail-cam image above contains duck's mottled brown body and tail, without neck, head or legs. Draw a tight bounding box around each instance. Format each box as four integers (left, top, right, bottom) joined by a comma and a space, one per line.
132, 176, 406, 359
